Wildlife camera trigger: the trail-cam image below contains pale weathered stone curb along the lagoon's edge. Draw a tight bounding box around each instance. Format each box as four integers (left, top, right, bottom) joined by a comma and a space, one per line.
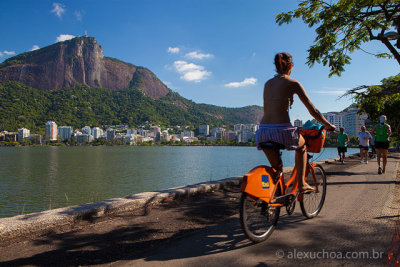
0, 177, 242, 243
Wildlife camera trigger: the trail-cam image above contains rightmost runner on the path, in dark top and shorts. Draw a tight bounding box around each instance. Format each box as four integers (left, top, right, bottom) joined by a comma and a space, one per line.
372, 115, 392, 174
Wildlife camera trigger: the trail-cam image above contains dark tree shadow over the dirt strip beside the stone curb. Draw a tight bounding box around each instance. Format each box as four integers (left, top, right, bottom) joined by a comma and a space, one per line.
0, 188, 249, 266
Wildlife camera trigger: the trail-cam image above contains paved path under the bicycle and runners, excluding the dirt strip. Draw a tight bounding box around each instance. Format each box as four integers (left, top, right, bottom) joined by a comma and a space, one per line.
113, 154, 400, 266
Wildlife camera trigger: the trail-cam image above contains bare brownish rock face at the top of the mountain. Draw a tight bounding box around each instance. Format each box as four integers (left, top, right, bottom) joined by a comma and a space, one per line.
0, 37, 170, 99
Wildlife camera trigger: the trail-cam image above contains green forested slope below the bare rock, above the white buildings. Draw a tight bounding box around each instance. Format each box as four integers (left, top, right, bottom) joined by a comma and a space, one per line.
0, 81, 262, 132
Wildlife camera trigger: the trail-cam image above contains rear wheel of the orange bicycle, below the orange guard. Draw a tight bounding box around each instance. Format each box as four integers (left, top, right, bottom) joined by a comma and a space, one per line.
240, 186, 281, 243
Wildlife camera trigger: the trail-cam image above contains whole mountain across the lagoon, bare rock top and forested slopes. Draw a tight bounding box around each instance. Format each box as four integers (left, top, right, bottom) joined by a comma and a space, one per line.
0, 37, 263, 130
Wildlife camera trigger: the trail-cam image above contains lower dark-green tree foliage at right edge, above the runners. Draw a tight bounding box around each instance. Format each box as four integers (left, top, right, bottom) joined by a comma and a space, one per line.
345, 74, 400, 137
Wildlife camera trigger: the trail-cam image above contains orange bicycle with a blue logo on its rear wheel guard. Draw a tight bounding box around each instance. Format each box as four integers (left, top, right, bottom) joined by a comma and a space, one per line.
240, 130, 326, 243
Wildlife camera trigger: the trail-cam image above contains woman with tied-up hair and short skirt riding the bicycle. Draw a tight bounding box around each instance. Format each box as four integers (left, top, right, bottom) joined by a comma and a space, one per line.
255, 53, 335, 193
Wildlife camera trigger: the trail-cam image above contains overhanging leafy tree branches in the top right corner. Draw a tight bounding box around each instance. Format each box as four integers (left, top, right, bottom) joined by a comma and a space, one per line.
276, 0, 400, 76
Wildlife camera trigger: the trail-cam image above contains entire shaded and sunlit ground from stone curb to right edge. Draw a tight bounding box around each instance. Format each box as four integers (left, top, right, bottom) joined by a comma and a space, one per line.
0, 154, 400, 266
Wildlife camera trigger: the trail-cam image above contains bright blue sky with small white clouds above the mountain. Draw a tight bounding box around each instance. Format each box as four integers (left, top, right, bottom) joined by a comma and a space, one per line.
0, 0, 399, 121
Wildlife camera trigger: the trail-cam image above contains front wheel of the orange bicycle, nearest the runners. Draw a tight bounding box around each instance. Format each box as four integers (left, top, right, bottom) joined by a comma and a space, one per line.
300, 164, 326, 219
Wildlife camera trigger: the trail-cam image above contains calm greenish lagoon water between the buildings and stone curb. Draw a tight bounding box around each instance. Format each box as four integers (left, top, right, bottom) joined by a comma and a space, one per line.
0, 146, 358, 217
